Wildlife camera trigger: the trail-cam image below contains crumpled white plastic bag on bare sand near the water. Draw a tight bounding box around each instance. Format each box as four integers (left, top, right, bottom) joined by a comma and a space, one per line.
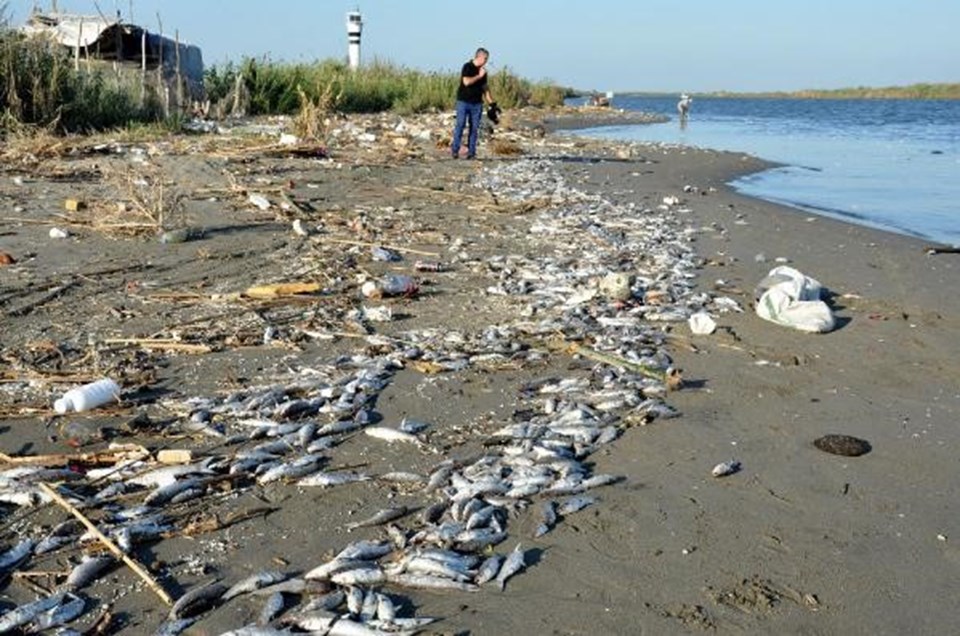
754, 265, 835, 333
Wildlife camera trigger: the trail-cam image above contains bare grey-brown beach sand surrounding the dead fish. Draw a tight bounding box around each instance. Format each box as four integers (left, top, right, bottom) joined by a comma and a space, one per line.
0, 108, 960, 634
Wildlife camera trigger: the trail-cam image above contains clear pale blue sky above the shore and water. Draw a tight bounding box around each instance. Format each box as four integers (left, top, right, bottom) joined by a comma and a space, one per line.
8, 0, 960, 92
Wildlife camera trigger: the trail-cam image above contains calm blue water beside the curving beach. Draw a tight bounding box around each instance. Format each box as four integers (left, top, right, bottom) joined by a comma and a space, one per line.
579, 95, 960, 245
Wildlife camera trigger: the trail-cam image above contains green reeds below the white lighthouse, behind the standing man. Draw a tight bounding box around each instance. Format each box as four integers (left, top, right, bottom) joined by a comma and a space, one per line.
205, 58, 566, 115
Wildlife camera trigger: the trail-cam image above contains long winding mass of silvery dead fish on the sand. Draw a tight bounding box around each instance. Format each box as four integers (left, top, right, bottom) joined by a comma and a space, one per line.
0, 160, 709, 634
